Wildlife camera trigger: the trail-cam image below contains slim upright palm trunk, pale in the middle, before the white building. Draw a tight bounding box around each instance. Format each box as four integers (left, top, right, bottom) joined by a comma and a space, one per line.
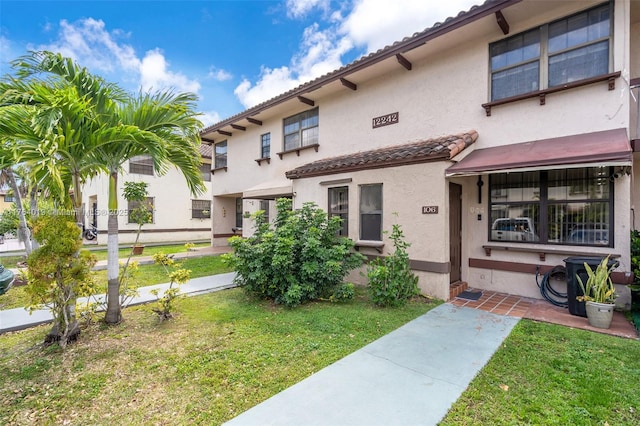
104, 172, 122, 324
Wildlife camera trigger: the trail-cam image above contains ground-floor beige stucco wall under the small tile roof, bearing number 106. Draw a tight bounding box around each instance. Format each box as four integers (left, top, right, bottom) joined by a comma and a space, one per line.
293, 162, 449, 300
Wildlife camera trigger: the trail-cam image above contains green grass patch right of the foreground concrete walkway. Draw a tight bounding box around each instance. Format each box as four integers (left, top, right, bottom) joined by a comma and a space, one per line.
441, 320, 640, 426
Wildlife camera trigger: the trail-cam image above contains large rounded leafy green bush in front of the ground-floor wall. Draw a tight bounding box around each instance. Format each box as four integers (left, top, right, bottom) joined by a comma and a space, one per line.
224, 198, 364, 307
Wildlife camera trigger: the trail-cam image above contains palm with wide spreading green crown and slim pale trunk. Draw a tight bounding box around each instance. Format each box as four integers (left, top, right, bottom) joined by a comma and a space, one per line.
0, 52, 204, 324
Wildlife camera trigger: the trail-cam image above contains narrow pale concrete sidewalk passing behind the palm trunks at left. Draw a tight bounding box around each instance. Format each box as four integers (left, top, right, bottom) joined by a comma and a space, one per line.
0, 272, 235, 334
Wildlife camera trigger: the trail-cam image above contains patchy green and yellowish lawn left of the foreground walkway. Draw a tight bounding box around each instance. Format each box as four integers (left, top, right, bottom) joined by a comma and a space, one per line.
0, 289, 435, 425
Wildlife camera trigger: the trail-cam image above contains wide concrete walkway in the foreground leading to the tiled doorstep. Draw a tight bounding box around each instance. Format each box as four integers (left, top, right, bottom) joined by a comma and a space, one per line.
225, 303, 519, 426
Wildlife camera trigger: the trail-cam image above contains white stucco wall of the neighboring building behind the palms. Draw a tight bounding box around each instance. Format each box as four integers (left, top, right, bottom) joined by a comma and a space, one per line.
82, 166, 211, 244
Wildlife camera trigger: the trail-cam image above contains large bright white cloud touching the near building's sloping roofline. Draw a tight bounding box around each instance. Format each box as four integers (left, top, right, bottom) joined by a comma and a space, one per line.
234, 0, 477, 108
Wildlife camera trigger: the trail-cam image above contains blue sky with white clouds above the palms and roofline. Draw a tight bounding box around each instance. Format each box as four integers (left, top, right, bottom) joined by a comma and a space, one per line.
0, 0, 482, 125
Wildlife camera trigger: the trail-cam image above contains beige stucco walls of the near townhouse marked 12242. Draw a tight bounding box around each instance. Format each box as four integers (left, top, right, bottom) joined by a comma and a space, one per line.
212, 0, 640, 299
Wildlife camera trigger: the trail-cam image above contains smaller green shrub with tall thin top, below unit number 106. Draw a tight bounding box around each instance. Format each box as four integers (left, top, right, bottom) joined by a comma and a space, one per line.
367, 224, 420, 306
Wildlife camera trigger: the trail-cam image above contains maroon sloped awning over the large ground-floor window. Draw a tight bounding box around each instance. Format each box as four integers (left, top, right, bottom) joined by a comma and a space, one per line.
445, 129, 633, 177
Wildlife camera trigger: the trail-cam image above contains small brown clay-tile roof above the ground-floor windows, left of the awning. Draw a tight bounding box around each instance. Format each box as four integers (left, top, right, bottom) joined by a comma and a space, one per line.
285, 130, 478, 179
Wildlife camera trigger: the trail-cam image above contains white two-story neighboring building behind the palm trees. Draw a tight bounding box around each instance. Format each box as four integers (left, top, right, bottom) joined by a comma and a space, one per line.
82, 144, 212, 244
